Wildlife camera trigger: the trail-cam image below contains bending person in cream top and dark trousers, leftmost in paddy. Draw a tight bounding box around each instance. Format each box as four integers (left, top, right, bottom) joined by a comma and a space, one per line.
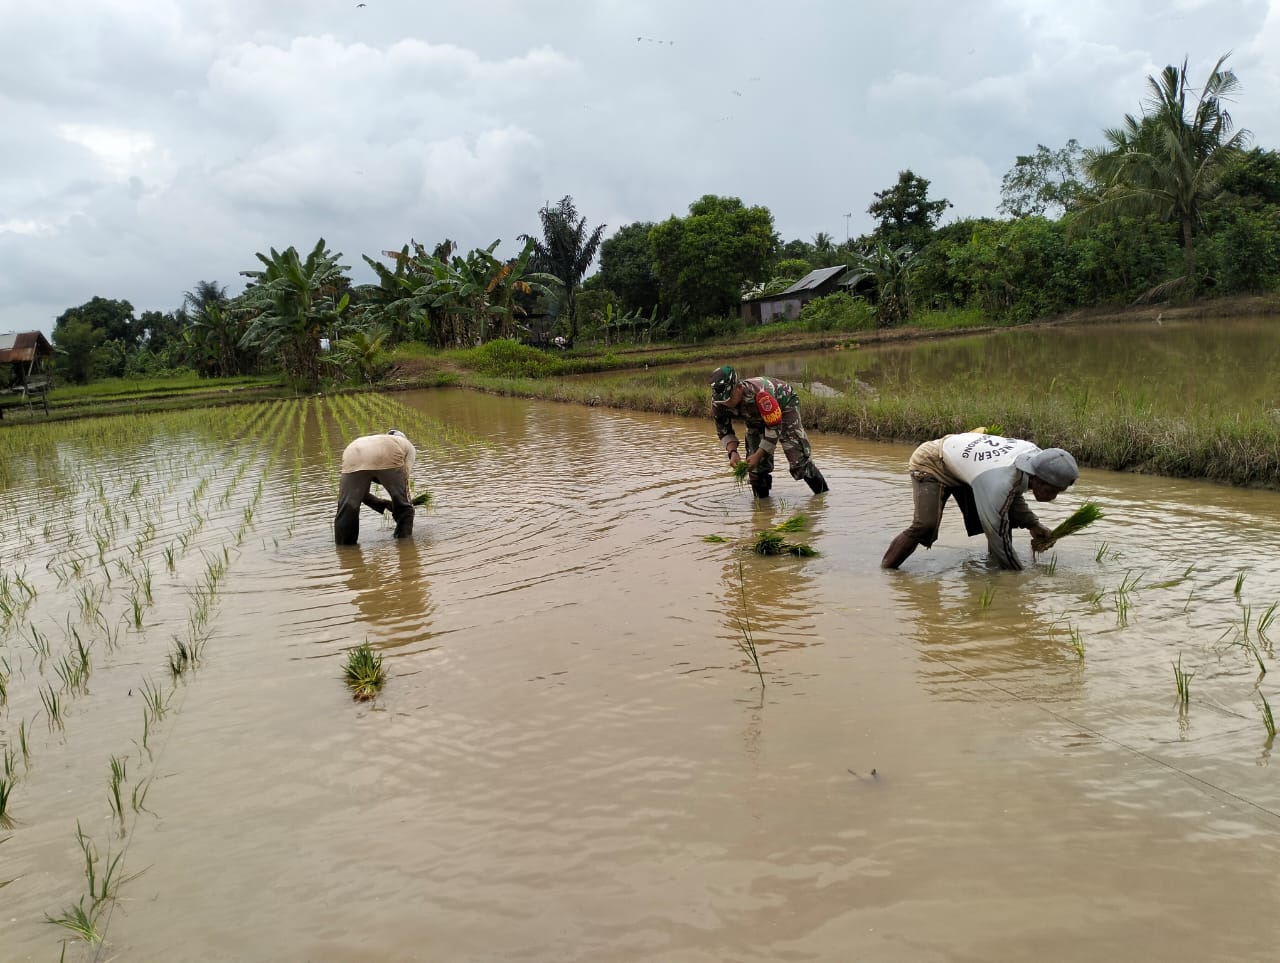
333, 428, 416, 546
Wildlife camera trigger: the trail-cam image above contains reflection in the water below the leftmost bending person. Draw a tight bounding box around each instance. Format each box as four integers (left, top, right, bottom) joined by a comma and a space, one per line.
334, 538, 434, 648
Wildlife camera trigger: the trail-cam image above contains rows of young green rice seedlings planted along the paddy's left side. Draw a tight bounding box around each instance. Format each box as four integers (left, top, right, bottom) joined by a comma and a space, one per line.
0, 394, 448, 951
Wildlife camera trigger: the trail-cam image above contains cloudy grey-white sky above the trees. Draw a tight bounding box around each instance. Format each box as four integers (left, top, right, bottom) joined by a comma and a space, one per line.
0, 0, 1280, 332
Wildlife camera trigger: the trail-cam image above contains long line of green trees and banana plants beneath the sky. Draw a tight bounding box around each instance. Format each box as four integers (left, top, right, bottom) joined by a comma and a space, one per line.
40, 56, 1280, 385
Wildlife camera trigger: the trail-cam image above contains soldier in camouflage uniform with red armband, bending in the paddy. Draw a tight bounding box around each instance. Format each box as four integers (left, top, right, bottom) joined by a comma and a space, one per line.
712, 365, 828, 498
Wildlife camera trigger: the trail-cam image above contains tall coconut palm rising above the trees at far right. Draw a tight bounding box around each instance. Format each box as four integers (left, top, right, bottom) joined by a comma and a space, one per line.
1082, 54, 1252, 289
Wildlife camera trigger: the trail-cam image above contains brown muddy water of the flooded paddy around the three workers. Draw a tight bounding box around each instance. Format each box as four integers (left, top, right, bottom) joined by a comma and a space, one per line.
0, 392, 1280, 962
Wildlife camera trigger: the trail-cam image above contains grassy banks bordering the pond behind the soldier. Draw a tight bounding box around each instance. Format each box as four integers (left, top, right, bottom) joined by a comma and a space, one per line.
435, 298, 1280, 488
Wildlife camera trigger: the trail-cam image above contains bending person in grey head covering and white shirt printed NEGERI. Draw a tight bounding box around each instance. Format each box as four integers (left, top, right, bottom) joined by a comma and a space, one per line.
881, 432, 1080, 569
